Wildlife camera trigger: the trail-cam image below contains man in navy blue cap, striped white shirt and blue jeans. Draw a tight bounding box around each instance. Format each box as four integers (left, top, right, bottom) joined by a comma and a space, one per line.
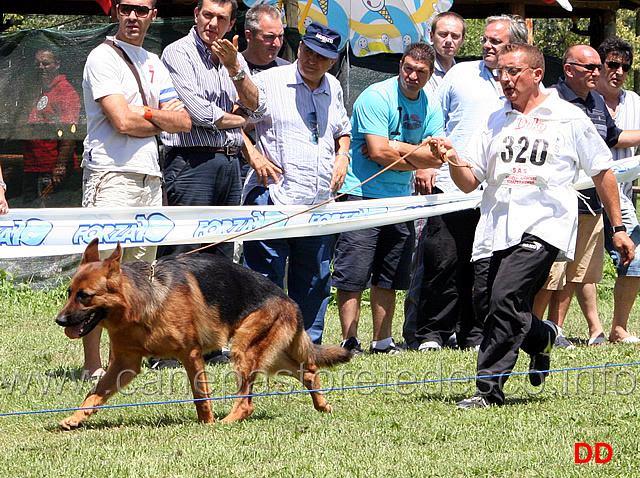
243, 22, 351, 343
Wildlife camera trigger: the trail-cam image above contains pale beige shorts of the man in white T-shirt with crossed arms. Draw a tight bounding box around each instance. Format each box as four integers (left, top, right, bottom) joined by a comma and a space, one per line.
82, 169, 162, 262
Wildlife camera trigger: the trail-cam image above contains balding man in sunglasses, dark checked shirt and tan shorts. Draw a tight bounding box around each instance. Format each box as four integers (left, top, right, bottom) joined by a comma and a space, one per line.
534, 45, 640, 348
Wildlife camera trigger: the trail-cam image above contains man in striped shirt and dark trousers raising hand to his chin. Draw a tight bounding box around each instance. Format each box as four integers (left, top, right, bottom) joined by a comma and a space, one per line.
162, 0, 261, 258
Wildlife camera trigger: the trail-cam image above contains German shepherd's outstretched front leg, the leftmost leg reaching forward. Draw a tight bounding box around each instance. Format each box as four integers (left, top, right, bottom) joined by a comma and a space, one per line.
60, 355, 142, 430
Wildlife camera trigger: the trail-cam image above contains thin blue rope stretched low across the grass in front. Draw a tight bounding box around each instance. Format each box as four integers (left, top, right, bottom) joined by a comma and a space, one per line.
0, 362, 640, 417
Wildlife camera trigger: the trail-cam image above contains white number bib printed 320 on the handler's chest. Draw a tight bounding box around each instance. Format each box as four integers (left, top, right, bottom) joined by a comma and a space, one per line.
491, 115, 558, 188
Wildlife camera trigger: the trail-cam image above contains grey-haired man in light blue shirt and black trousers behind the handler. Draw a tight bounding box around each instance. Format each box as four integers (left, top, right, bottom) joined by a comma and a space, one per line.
405, 15, 528, 351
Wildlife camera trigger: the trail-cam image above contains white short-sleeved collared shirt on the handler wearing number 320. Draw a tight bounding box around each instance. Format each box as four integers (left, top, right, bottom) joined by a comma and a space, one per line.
462, 95, 613, 261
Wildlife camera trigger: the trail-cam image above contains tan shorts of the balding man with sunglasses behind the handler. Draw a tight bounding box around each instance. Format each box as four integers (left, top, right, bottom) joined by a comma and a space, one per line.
542, 214, 604, 290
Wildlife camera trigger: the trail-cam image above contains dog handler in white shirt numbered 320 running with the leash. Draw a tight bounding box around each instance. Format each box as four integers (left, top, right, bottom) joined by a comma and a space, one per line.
440, 43, 634, 409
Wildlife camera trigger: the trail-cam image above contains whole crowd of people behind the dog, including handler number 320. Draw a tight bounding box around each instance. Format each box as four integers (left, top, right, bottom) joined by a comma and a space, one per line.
5, 0, 640, 408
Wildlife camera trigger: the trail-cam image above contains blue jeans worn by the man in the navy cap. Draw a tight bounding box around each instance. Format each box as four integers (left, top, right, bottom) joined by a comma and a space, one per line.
243, 186, 336, 344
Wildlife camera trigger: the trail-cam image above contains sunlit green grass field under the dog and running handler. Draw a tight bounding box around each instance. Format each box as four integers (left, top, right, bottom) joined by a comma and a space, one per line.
0, 269, 640, 478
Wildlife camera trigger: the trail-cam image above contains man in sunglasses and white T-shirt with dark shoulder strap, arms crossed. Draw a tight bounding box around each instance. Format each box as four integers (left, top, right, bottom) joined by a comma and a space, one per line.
82, 0, 191, 377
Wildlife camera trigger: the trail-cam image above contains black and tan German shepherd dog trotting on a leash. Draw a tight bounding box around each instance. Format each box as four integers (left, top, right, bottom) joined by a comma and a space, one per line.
56, 239, 350, 430
